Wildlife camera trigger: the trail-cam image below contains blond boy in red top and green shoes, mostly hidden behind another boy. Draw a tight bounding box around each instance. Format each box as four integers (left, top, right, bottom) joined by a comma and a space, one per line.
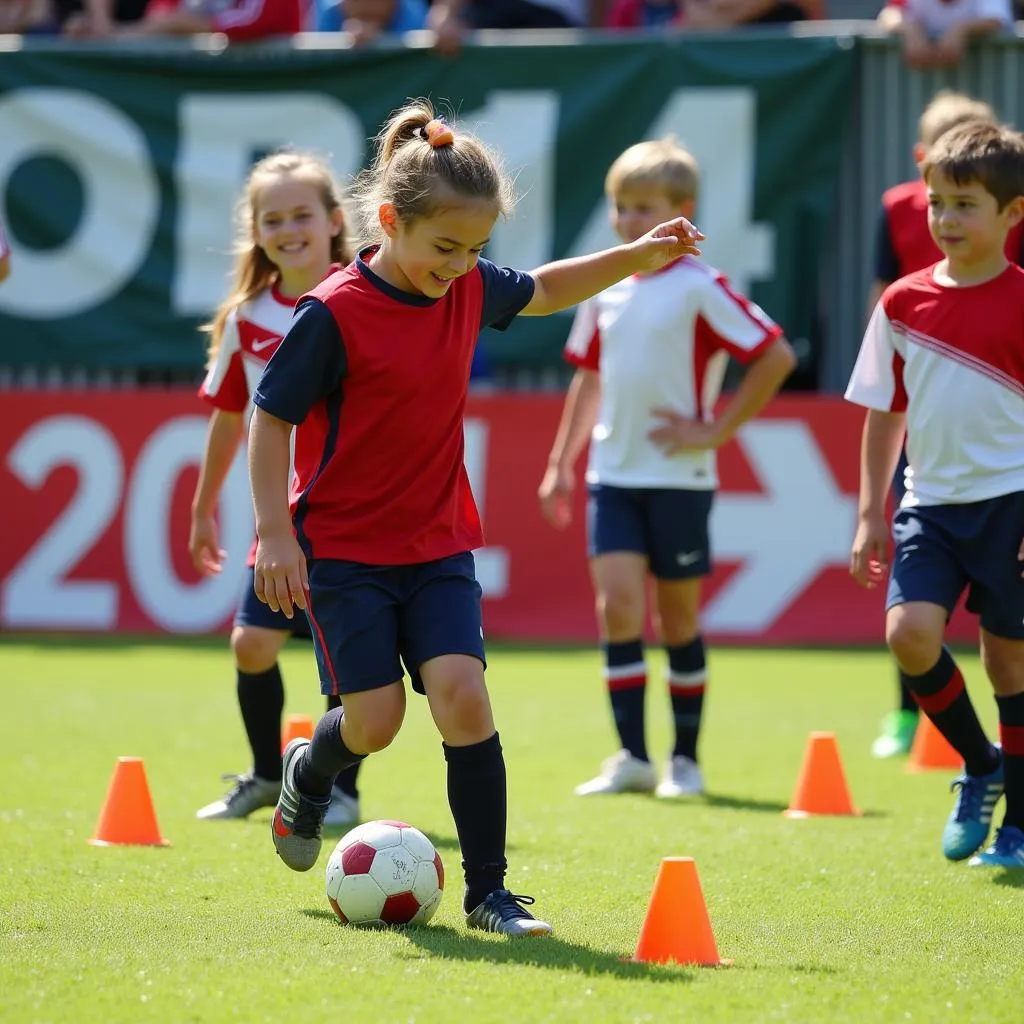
867, 89, 1024, 758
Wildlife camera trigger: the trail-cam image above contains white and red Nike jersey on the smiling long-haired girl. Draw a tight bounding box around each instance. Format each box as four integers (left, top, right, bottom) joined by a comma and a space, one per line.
199, 288, 295, 413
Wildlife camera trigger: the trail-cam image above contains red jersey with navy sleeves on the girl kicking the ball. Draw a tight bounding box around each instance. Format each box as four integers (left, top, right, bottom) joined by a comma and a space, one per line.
253, 250, 534, 565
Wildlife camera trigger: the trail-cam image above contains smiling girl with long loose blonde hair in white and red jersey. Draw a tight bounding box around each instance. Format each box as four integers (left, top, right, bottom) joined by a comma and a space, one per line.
188, 152, 358, 824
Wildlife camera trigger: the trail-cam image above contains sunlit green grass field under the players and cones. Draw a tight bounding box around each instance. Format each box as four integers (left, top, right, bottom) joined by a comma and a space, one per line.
0, 639, 1024, 1024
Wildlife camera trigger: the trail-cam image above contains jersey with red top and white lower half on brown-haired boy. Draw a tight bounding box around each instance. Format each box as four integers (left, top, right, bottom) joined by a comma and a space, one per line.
846, 266, 1024, 507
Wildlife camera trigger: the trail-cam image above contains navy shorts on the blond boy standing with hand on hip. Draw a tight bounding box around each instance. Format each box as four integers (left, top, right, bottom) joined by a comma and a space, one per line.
587, 483, 715, 580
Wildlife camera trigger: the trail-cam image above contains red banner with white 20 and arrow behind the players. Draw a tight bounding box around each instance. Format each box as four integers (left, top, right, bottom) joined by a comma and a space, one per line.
0, 390, 977, 644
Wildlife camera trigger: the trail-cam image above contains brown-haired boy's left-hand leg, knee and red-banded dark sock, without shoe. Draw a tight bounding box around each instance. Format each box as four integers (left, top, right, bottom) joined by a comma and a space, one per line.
886, 601, 998, 776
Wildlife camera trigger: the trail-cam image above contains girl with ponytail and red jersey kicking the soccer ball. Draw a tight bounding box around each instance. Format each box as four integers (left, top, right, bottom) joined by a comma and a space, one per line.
249, 101, 702, 935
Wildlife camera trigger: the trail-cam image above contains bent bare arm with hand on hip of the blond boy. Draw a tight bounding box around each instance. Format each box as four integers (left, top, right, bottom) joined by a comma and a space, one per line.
647, 338, 797, 455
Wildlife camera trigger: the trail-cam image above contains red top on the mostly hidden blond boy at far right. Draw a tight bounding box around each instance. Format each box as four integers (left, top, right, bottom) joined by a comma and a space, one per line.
876, 178, 1024, 281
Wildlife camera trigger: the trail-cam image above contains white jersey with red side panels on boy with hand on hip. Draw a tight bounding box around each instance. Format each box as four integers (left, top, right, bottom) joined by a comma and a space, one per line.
565, 256, 782, 490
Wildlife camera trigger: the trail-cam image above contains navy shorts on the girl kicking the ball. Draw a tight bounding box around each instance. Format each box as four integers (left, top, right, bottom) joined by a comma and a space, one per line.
308, 551, 486, 694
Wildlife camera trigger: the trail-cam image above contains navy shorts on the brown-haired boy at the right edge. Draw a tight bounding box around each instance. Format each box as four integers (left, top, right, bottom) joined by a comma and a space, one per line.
886, 492, 1024, 640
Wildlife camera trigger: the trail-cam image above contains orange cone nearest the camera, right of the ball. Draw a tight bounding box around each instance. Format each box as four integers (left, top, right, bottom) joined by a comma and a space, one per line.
633, 857, 732, 967
